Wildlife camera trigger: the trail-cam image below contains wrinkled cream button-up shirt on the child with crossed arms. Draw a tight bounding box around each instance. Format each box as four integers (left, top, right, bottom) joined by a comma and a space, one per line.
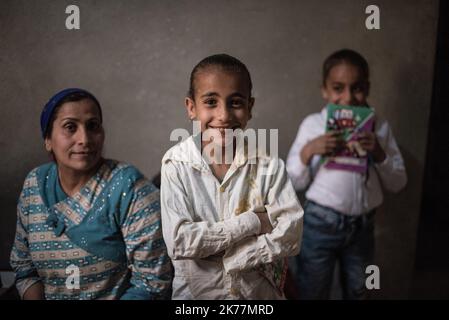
161, 137, 303, 299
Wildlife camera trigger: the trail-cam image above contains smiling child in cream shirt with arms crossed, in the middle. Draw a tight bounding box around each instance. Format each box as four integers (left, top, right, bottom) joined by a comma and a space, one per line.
161, 54, 303, 299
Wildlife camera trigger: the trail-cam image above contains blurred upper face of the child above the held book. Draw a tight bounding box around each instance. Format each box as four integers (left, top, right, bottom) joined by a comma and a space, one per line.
321, 63, 369, 106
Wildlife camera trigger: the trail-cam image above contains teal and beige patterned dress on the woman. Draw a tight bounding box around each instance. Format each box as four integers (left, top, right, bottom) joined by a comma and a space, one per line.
11, 160, 172, 300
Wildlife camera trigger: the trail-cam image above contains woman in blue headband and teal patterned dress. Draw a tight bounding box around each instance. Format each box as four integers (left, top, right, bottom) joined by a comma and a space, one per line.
11, 89, 171, 299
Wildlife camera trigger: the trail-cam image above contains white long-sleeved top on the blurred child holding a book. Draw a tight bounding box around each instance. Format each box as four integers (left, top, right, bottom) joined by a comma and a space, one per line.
287, 108, 407, 215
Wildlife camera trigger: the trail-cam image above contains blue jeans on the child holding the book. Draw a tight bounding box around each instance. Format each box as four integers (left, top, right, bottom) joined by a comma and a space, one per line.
290, 201, 374, 300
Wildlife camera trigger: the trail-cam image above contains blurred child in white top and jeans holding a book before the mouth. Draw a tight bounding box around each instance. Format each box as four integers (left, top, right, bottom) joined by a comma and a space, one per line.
287, 50, 407, 299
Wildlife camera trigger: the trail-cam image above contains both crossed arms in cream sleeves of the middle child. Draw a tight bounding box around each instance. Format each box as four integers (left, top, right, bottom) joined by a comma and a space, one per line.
161, 161, 303, 272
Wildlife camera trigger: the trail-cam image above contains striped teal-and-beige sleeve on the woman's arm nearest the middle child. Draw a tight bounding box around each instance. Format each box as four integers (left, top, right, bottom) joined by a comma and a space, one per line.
120, 178, 173, 300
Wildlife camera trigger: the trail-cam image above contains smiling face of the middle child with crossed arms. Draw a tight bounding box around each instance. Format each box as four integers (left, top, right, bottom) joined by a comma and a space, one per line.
185, 67, 254, 145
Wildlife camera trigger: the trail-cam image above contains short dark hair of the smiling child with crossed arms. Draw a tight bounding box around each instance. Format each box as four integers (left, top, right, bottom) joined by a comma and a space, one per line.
187, 53, 253, 100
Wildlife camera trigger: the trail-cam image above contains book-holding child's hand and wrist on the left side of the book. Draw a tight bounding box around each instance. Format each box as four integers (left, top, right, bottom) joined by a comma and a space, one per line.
300, 131, 345, 165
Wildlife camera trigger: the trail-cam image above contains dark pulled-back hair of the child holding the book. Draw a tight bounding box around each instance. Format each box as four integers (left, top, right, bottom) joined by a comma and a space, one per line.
323, 49, 369, 86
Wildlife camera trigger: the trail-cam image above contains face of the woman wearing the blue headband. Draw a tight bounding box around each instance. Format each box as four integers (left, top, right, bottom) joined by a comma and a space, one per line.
45, 99, 104, 174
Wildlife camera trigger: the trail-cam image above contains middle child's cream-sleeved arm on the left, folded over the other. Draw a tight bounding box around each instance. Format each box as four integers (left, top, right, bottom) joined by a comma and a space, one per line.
161, 162, 262, 260
